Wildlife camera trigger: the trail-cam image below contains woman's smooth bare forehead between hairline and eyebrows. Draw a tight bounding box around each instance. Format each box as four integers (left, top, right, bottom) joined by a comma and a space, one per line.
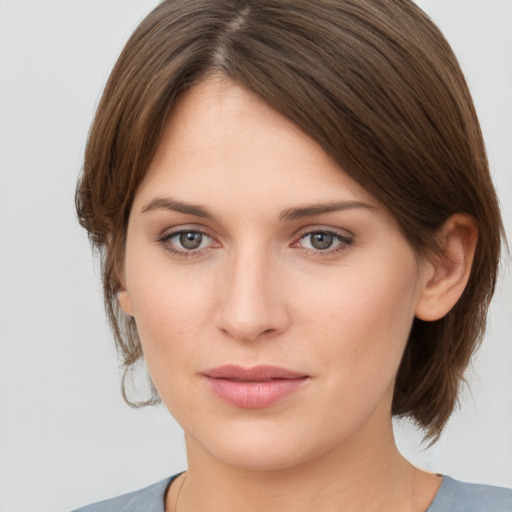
138, 77, 377, 212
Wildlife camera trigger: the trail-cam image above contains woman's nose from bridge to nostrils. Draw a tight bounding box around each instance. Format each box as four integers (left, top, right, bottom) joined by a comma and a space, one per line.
216, 250, 290, 341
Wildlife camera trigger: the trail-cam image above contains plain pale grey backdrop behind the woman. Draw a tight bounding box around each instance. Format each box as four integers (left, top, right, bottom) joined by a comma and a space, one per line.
0, 0, 512, 512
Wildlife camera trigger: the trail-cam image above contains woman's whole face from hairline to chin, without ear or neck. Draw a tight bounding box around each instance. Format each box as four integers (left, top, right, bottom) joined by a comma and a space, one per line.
119, 78, 425, 469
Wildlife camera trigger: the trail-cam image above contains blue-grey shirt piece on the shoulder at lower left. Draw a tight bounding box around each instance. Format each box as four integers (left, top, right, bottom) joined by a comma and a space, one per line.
73, 475, 178, 512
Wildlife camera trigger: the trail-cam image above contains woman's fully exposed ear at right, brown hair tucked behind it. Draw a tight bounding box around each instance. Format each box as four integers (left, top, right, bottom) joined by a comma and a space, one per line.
415, 214, 478, 321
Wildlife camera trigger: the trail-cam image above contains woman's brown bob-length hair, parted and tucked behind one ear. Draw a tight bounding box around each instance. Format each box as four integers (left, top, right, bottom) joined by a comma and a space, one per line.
76, 0, 504, 440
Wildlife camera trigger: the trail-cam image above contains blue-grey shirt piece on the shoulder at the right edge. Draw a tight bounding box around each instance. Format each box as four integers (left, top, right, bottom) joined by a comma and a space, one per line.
427, 476, 512, 512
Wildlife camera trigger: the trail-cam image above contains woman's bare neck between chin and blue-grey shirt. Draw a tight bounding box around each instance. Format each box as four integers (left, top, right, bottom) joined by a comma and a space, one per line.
167, 424, 440, 512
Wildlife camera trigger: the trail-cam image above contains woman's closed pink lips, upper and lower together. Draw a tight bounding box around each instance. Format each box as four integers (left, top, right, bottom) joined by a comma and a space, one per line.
202, 365, 309, 409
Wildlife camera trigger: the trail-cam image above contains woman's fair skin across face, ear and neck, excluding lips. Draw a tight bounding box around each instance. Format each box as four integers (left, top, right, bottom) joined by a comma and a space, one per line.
119, 77, 476, 512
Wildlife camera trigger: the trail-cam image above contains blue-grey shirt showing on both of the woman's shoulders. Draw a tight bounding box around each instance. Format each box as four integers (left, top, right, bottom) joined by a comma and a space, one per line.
74, 475, 512, 512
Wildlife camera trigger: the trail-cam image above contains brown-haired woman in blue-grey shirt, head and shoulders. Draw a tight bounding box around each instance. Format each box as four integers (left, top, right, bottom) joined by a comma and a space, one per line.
77, 0, 512, 512
